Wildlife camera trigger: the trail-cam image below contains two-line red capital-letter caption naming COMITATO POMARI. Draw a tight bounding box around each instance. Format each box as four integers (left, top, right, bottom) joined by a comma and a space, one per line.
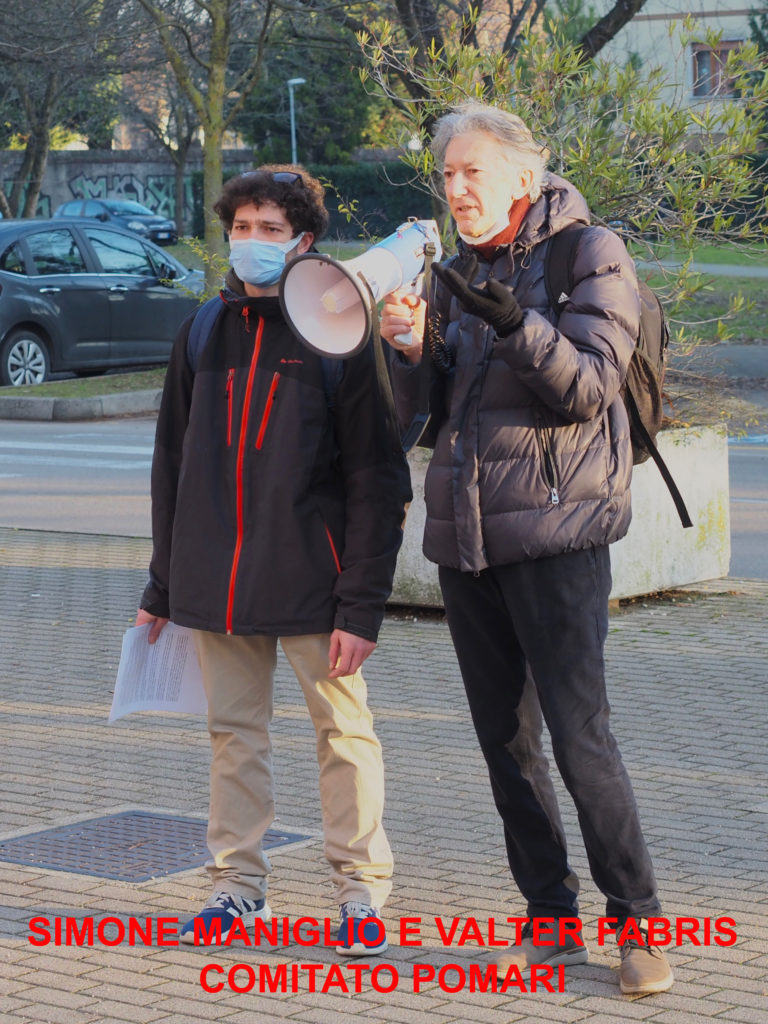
27, 916, 737, 994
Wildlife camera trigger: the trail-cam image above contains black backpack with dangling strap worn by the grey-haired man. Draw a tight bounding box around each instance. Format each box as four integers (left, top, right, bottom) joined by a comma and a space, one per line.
545, 225, 693, 526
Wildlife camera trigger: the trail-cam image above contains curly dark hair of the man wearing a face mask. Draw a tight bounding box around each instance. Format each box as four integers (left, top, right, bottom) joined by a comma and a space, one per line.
213, 164, 329, 241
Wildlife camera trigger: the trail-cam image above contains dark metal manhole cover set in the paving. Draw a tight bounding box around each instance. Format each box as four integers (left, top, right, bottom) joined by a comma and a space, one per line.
0, 811, 309, 882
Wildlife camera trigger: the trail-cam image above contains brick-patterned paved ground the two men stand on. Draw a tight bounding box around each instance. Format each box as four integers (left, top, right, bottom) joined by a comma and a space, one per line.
0, 529, 768, 1024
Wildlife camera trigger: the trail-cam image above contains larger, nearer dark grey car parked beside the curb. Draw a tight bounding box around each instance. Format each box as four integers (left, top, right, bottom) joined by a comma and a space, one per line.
0, 218, 204, 385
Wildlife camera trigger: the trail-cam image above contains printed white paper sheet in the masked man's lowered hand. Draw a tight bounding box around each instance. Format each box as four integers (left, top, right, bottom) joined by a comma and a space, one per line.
109, 623, 208, 722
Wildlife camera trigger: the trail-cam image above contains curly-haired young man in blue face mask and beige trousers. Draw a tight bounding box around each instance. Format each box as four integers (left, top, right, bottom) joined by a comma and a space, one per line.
136, 165, 411, 956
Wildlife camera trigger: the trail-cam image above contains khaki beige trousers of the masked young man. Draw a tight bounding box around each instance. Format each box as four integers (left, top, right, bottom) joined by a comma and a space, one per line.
195, 630, 392, 907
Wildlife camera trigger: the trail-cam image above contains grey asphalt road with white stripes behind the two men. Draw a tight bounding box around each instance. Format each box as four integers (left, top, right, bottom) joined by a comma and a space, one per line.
0, 417, 768, 580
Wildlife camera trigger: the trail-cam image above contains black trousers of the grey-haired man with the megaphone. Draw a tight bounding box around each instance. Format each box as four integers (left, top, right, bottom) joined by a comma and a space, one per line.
439, 548, 660, 919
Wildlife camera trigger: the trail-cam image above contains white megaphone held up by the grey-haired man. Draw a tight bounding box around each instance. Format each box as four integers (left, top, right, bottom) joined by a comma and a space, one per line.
280, 220, 442, 359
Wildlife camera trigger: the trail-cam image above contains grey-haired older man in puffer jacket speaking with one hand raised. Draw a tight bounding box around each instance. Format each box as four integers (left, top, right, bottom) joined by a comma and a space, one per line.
382, 102, 673, 994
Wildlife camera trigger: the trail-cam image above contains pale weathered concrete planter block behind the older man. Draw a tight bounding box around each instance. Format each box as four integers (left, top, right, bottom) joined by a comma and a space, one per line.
391, 427, 730, 607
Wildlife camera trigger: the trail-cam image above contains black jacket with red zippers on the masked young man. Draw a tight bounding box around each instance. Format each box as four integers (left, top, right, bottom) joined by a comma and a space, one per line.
141, 274, 411, 641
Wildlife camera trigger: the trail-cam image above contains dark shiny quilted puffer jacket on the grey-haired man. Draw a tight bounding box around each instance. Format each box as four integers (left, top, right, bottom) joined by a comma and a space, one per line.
393, 175, 639, 571
